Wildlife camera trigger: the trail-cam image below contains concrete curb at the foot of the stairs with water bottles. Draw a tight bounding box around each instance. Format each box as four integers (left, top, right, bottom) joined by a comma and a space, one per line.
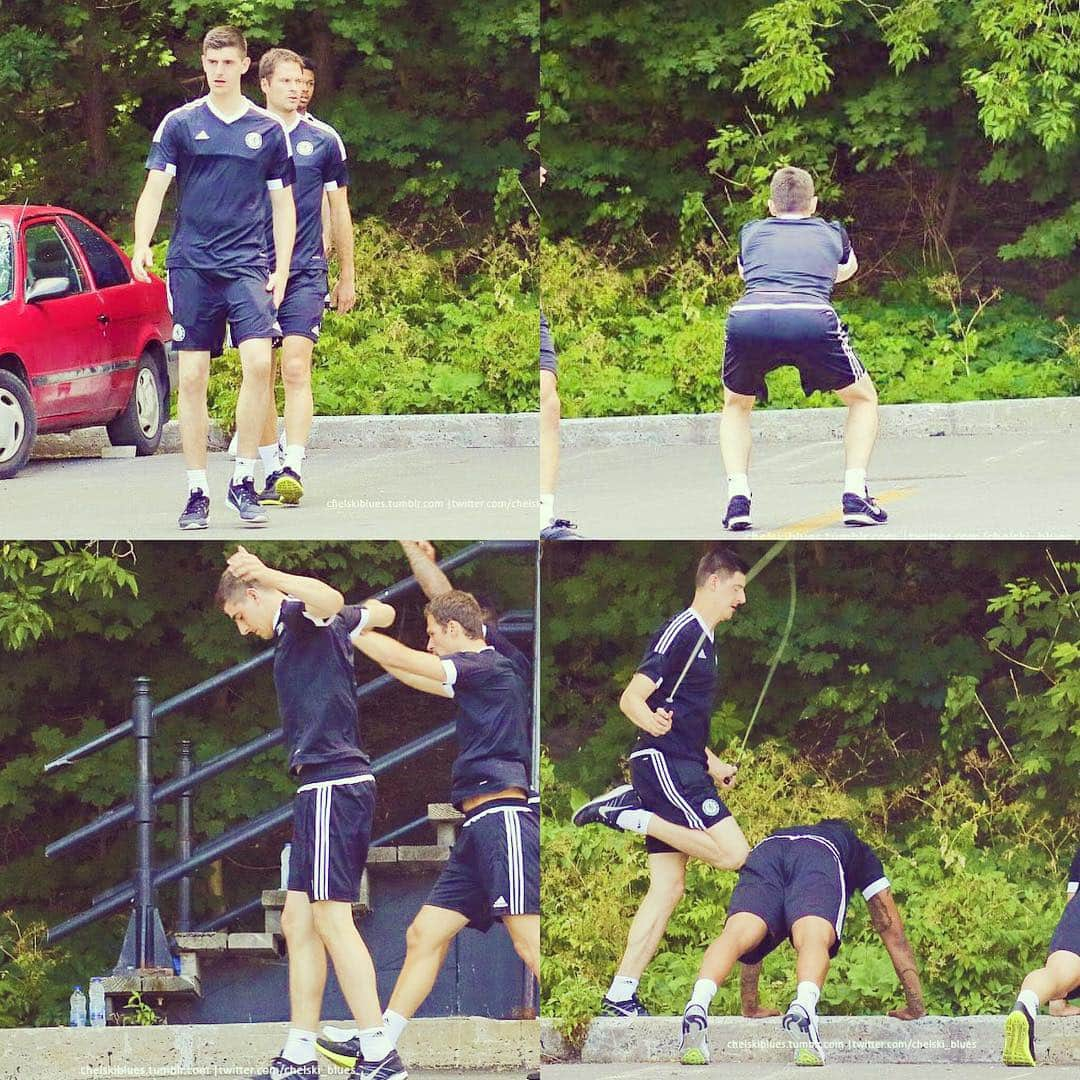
0, 1016, 540, 1080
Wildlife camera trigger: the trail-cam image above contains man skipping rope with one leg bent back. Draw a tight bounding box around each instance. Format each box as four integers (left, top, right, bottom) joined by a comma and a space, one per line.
573, 549, 750, 1016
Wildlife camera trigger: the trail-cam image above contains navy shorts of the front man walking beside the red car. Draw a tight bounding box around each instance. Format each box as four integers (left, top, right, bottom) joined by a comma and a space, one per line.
165, 267, 281, 356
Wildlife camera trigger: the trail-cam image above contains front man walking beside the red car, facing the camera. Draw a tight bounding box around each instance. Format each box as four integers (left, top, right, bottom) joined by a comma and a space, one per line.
132, 26, 296, 529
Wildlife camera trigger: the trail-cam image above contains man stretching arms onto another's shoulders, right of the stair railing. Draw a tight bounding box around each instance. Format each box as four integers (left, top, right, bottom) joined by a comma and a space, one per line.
319, 590, 540, 1065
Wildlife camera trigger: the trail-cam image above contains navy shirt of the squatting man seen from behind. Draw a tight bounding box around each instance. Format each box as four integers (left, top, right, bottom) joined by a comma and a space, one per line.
739, 217, 851, 300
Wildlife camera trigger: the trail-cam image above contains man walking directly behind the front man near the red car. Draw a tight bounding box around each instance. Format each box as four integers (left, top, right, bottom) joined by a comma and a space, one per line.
259, 49, 356, 507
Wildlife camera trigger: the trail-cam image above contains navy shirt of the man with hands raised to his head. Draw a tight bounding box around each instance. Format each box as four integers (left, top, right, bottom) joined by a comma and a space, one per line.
273, 596, 370, 779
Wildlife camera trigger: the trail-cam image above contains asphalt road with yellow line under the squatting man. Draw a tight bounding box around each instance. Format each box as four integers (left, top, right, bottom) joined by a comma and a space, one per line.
558, 430, 1080, 540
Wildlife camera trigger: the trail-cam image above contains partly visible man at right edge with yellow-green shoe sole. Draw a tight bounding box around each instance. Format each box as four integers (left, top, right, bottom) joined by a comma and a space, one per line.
1001, 848, 1080, 1066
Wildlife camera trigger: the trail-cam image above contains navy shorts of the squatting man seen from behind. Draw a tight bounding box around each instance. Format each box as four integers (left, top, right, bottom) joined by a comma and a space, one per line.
724, 293, 866, 402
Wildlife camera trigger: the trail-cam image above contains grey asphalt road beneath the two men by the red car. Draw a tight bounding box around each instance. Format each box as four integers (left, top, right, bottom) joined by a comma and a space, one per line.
0, 446, 538, 540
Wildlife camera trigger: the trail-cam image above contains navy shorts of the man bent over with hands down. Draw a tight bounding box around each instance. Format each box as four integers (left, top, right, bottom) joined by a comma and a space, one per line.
728, 836, 848, 963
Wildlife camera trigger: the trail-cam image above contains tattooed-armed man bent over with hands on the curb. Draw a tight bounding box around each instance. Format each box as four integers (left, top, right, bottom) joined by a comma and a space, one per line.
679, 820, 926, 1065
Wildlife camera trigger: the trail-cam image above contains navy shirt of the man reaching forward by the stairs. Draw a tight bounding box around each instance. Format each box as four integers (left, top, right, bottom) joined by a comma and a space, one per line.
441, 645, 531, 809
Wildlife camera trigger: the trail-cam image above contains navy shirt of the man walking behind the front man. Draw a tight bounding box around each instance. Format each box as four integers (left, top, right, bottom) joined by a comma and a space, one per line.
264, 113, 349, 270
